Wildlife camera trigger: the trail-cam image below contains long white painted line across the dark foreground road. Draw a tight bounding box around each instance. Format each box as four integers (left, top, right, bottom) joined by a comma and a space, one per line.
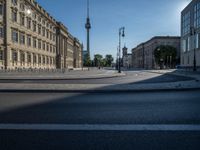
0, 124, 200, 131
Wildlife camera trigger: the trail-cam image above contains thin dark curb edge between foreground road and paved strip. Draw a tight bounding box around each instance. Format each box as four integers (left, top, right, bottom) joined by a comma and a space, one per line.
0, 88, 200, 94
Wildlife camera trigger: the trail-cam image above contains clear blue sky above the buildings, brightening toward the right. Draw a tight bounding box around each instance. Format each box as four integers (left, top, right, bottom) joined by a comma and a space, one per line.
36, 0, 191, 57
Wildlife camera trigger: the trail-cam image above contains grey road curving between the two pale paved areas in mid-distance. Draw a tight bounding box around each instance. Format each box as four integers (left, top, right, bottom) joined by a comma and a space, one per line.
0, 71, 194, 84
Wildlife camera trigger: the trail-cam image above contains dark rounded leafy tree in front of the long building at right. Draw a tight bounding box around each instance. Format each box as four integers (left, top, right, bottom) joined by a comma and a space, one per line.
154, 45, 177, 69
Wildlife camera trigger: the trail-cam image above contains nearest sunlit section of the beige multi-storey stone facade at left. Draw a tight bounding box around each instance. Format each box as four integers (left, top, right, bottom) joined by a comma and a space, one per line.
0, 0, 81, 69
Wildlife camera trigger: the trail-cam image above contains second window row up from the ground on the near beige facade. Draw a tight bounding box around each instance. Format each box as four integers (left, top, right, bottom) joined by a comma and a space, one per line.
12, 29, 56, 53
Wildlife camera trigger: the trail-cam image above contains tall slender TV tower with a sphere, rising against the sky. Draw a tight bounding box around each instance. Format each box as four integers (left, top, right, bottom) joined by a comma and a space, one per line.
85, 0, 91, 57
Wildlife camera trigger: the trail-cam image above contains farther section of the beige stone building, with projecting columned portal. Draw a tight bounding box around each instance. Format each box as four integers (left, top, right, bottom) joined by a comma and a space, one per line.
56, 22, 82, 69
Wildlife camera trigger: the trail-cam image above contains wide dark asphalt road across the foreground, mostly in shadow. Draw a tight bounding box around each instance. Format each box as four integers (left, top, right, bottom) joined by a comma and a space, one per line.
0, 90, 200, 150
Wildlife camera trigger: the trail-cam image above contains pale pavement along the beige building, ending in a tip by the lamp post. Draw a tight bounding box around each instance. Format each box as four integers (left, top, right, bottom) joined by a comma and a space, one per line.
0, 70, 125, 80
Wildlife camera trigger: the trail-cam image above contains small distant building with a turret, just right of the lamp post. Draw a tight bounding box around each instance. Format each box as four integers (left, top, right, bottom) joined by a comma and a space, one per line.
122, 46, 132, 68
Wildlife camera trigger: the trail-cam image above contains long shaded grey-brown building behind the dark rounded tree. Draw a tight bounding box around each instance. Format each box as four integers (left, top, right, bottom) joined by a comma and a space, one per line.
132, 36, 180, 69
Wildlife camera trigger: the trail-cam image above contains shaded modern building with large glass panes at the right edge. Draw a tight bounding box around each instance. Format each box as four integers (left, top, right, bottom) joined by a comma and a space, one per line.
181, 0, 200, 68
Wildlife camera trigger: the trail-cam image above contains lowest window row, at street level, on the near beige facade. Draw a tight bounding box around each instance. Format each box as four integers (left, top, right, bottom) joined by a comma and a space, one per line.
12, 50, 55, 65
